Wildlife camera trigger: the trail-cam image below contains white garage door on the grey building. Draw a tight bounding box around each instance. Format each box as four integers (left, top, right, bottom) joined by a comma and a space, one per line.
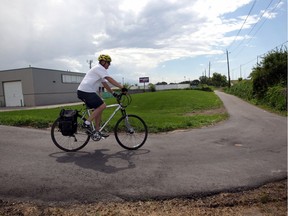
4, 81, 24, 107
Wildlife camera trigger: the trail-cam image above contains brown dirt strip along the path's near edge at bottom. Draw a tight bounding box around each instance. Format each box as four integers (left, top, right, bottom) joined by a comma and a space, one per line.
0, 180, 287, 216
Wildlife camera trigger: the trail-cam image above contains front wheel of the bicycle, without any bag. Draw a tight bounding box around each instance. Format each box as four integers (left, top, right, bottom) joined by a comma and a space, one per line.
114, 115, 148, 150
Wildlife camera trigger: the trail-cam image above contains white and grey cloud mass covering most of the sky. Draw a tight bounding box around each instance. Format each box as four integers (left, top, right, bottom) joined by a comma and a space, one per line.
0, 0, 282, 83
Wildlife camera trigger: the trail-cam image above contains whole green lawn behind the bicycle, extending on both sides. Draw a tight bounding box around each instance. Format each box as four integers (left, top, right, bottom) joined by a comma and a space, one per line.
0, 90, 227, 133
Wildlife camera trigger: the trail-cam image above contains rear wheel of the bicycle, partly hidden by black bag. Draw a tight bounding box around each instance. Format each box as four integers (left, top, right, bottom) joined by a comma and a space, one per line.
51, 117, 90, 152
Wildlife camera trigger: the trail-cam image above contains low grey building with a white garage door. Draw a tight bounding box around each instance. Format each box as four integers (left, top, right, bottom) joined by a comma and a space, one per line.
0, 67, 85, 107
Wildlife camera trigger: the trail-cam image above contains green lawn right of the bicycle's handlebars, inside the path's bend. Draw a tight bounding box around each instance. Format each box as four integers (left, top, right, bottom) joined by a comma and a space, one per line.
128, 90, 226, 132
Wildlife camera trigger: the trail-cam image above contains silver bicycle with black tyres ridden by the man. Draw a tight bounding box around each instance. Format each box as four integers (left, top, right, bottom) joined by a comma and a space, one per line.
51, 93, 148, 152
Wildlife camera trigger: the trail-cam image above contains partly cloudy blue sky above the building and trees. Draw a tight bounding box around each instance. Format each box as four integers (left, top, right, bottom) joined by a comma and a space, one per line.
0, 0, 287, 85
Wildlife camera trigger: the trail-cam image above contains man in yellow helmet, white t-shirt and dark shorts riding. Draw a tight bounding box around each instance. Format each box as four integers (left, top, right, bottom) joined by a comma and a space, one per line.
77, 54, 127, 137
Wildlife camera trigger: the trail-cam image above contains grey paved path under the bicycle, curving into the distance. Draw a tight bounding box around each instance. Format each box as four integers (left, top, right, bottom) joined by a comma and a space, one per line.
0, 92, 287, 202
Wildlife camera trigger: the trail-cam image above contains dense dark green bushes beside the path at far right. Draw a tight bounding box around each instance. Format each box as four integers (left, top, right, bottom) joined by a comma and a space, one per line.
225, 47, 287, 112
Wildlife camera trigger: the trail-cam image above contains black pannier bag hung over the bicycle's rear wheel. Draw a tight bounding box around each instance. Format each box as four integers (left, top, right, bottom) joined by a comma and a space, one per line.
59, 109, 78, 136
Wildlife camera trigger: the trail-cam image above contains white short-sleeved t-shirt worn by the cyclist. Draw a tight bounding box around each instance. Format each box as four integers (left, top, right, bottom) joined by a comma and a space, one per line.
78, 64, 109, 92
